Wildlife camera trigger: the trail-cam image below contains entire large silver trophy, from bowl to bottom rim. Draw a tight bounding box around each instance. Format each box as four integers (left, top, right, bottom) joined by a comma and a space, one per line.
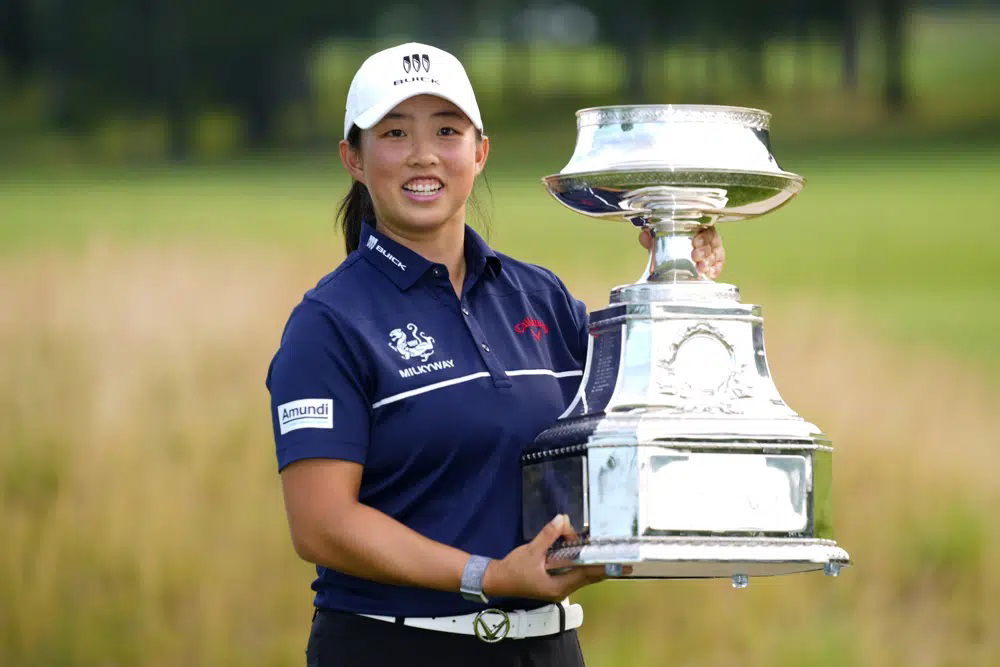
522, 105, 850, 587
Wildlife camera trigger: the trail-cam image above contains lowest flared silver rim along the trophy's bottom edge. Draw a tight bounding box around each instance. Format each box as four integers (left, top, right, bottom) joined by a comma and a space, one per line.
549, 535, 850, 581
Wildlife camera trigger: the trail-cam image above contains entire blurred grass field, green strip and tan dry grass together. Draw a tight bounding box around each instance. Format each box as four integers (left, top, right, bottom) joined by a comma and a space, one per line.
0, 137, 1000, 667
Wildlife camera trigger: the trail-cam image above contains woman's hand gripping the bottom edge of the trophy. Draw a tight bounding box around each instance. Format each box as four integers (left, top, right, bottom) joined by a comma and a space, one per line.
483, 514, 606, 602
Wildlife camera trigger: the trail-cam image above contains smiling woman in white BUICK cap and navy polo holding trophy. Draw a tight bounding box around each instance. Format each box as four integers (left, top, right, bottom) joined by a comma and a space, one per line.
267, 43, 723, 667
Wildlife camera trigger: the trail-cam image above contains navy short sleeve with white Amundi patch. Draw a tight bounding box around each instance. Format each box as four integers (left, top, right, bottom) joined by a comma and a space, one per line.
265, 299, 372, 471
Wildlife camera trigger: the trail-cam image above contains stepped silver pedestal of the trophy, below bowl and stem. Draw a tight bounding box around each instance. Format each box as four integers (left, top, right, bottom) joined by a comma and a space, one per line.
521, 254, 850, 587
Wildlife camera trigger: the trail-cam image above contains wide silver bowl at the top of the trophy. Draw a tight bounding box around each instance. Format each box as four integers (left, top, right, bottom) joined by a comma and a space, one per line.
543, 105, 803, 226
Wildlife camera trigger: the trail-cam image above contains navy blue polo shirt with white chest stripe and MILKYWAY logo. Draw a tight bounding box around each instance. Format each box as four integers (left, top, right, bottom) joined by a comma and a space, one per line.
267, 225, 587, 616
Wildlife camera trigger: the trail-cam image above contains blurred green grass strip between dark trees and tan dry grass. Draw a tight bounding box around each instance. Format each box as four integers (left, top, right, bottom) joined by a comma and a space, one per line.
0, 140, 1000, 371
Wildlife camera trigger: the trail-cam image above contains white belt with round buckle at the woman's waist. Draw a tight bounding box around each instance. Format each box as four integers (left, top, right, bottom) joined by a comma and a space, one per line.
358, 603, 583, 643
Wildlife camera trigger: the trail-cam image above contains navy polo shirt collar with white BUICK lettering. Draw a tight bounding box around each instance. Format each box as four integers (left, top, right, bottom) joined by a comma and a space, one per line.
358, 222, 501, 290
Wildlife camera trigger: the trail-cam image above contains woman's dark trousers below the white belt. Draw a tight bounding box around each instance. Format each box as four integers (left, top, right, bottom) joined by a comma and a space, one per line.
306, 610, 583, 667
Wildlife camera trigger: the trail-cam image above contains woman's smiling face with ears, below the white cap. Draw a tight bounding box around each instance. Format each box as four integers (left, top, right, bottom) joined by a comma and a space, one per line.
340, 95, 489, 240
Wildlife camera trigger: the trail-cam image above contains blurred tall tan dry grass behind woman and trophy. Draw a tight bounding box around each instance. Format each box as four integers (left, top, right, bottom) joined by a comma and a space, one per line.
0, 242, 1000, 667
